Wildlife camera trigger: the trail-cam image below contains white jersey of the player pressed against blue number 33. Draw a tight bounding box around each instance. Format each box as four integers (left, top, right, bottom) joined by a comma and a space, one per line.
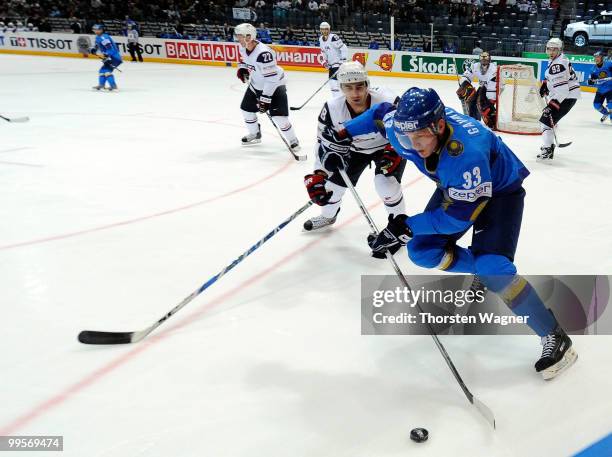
315, 87, 398, 170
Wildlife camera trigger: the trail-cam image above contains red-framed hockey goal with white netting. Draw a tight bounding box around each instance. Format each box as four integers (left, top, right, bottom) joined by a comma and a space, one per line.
497, 64, 544, 135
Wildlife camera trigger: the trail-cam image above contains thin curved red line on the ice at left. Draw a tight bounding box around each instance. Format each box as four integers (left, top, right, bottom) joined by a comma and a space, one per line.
0, 159, 294, 251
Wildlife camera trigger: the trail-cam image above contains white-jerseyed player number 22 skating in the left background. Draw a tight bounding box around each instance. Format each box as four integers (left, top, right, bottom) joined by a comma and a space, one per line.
234, 23, 300, 152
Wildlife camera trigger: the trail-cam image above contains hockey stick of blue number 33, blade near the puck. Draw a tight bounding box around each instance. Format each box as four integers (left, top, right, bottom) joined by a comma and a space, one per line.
338, 169, 495, 429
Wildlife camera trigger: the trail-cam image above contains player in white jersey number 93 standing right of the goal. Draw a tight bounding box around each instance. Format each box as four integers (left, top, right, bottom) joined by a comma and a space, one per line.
537, 38, 580, 160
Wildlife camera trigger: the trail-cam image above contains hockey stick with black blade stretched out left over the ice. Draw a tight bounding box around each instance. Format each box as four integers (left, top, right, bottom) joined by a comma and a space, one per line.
79, 201, 312, 344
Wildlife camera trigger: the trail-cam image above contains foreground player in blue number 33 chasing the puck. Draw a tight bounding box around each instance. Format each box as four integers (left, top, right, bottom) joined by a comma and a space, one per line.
322, 87, 577, 379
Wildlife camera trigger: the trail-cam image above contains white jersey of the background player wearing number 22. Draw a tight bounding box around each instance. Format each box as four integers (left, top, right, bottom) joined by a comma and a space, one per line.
238, 42, 285, 97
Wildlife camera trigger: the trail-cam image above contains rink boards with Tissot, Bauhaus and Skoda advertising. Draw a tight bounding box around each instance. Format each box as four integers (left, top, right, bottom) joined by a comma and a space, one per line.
0, 32, 595, 92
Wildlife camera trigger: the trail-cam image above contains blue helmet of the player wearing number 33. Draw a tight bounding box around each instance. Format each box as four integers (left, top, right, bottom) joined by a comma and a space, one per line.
393, 87, 445, 149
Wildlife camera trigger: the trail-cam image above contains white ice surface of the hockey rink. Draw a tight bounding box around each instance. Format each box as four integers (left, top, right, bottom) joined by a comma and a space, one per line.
0, 55, 612, 457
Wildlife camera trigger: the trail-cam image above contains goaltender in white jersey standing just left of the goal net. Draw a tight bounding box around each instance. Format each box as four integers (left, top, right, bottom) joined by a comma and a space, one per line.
457, 51, 497, 129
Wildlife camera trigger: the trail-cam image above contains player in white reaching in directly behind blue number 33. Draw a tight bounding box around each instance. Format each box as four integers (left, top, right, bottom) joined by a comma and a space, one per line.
304, 62, 406, 230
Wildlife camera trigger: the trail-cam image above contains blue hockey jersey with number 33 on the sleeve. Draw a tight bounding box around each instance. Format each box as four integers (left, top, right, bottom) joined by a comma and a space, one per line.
344, 103, 529, 235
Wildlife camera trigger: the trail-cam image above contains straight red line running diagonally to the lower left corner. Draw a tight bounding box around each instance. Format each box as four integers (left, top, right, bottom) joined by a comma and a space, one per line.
0, 176, 423, 436
